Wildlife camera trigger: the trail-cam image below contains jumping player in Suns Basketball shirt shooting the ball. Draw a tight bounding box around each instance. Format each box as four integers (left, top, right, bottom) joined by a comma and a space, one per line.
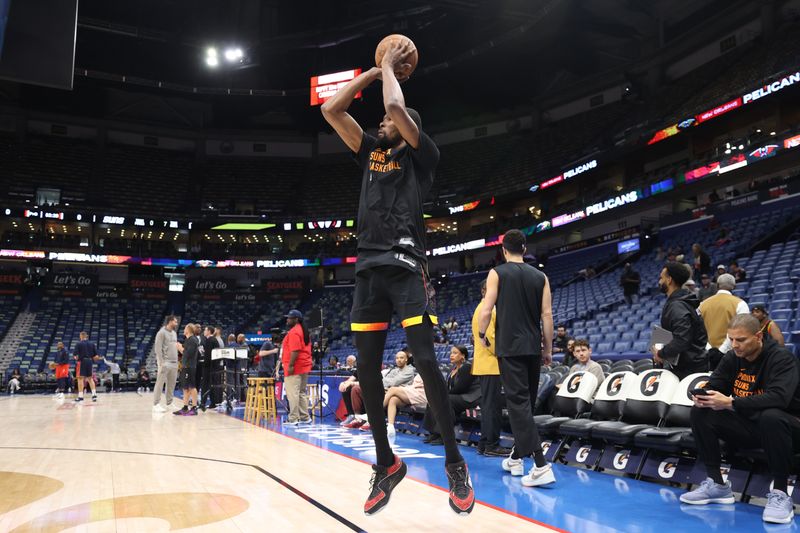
322, 40, 474, 515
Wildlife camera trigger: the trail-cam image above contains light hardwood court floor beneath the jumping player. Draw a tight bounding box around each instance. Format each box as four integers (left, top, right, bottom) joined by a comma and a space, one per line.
0, 393, 552, 533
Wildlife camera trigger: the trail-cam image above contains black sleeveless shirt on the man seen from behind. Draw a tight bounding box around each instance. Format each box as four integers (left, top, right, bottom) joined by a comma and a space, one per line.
494, 263, 547, 357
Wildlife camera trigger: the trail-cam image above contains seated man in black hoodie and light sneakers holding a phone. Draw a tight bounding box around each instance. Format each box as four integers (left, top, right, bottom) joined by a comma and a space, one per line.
680, 314, 800, 524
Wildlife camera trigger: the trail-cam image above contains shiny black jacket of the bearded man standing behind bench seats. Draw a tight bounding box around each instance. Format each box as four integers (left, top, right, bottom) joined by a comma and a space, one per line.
659, 289, 708, 379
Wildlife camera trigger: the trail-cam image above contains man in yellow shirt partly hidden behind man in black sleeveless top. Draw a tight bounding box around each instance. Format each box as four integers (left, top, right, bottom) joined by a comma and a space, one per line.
472, 280, 510, 457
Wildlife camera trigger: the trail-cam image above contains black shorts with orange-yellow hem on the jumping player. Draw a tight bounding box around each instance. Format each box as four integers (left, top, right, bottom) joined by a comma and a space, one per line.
350, 266, 439, 331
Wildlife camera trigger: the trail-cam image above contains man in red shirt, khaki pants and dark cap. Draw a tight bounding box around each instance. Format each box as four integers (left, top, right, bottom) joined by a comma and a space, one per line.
281, 309, 312, 425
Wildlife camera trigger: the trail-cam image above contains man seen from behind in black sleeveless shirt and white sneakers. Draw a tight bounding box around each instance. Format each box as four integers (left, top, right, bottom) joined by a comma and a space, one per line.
478, 229, 556, 487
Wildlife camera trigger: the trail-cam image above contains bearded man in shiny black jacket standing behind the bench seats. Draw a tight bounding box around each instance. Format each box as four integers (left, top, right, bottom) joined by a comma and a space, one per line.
652, 261, 708, 379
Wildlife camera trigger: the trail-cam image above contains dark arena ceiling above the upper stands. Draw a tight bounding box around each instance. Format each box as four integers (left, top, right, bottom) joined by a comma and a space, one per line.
1, 0, 759, 133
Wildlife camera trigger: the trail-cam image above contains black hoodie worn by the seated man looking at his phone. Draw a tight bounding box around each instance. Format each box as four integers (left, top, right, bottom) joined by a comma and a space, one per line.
706, 338, 800, 416
